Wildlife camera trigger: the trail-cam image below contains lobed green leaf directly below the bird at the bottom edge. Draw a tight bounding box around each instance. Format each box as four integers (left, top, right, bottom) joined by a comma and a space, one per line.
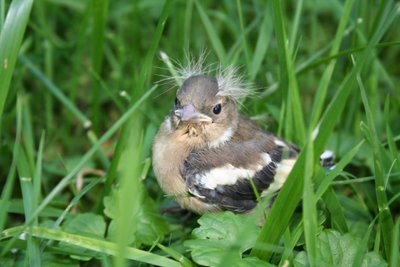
184, 212, 260, 266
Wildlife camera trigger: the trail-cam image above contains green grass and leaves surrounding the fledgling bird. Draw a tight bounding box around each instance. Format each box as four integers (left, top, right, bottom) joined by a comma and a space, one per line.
0, 0, 400, 266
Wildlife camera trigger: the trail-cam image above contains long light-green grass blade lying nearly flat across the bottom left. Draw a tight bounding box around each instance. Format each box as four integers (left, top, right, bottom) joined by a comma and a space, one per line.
0, 226, 181, 267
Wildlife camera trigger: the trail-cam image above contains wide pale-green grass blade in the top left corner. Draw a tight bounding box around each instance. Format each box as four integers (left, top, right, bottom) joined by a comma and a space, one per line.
0, 0, 33, 118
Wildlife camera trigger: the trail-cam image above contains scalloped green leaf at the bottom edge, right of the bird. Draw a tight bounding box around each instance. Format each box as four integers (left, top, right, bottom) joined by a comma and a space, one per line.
293, 230, 387, 267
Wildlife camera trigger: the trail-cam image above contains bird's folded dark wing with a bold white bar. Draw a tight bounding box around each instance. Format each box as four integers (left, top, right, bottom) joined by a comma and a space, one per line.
181, 136, 298, 212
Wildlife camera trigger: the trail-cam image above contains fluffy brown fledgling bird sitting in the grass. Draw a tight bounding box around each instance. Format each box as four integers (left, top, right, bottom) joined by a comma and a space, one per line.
152, 67, 332, 215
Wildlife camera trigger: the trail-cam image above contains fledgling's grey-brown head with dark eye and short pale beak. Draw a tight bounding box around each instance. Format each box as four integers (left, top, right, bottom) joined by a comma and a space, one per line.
170, 75, 238, 147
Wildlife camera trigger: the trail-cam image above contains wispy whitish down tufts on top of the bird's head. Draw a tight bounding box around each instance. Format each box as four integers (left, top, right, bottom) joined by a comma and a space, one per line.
160, 52, 252, 102
